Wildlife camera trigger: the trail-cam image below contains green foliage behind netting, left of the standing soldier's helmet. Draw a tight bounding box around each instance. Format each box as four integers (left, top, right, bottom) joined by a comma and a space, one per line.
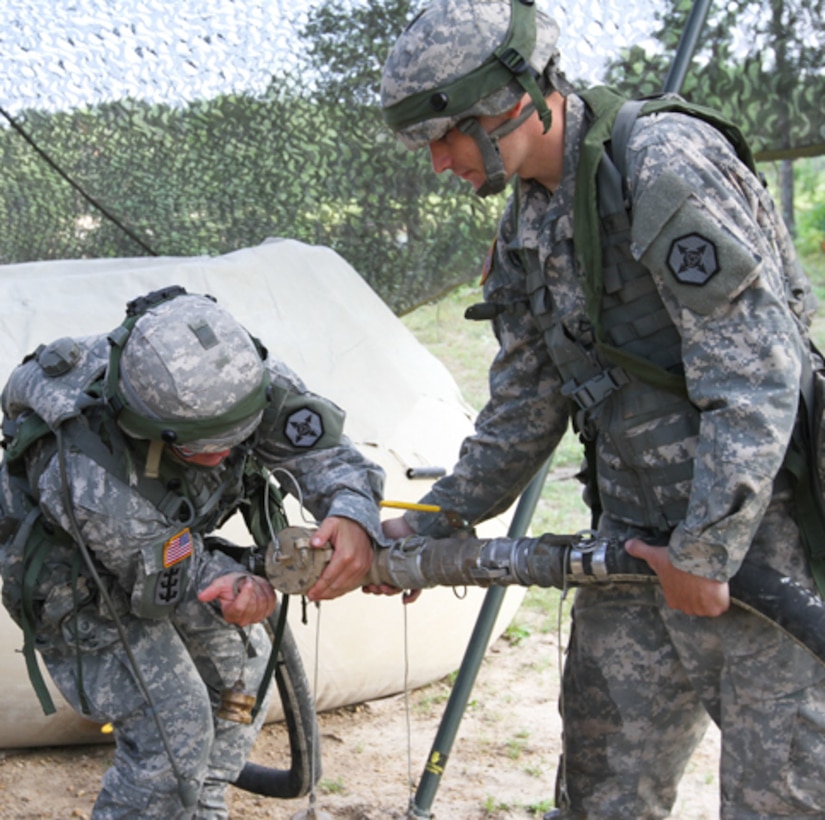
0, 0, 502, 313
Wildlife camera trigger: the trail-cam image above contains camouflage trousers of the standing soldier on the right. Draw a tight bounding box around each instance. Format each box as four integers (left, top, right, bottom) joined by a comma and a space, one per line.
557, 502, 825, 820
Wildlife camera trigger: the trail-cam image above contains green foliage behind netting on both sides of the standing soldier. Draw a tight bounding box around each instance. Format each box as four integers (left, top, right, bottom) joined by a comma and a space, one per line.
0, 0, 825, 318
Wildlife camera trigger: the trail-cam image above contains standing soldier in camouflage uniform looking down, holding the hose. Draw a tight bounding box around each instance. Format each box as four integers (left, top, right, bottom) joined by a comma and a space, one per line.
372, 0, 825, 820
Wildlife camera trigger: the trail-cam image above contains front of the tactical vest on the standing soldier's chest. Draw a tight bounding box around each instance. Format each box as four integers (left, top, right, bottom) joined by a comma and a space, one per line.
511, 88, 748, 533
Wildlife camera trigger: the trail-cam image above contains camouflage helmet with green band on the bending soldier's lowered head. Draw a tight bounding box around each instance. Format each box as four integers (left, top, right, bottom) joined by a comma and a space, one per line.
104, 286, 269, 470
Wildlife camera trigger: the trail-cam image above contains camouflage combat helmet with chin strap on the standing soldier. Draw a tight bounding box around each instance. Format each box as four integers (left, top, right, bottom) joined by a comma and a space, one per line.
381, 0, 569, 196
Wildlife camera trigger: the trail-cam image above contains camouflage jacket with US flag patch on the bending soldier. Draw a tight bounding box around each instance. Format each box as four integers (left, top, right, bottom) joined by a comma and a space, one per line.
4, 337, 383, 645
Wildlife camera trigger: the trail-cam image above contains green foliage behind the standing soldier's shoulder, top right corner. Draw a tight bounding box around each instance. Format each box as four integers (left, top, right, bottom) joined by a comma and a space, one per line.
606, 0, 825, 160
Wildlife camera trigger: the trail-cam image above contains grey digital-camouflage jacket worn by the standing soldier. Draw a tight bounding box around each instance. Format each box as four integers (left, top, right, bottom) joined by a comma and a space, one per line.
408, 91, 814, 580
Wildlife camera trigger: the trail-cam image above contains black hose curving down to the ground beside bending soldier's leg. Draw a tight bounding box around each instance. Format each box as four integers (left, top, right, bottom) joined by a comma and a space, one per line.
233, 610, 321, 799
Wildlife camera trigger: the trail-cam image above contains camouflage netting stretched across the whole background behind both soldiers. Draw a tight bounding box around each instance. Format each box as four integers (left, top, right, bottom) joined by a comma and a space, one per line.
0, 0, 825, 313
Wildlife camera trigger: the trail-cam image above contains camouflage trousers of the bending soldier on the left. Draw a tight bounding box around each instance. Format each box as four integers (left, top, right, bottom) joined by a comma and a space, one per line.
44, 598, 274, 820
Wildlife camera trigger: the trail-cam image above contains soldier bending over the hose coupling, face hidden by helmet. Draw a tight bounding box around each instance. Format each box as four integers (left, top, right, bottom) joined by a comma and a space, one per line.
0, 288, 383, 820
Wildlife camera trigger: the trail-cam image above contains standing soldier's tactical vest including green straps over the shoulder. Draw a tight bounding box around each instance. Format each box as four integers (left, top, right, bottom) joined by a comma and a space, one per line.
492, 88, 825, 594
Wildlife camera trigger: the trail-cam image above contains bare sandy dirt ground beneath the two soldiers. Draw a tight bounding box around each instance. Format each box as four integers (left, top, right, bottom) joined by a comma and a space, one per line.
0, 607, 718, 820
